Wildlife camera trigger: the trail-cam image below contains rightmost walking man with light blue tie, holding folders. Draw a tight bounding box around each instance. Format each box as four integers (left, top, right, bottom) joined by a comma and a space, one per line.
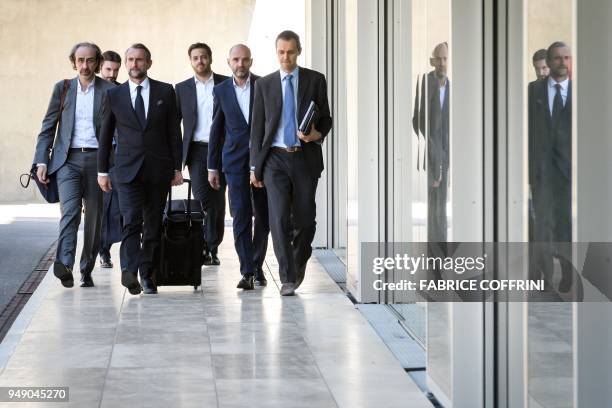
250, 31, 332, 296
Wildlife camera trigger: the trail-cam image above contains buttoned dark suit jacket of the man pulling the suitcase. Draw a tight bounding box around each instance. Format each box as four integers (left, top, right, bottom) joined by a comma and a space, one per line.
98, 78, 181, 183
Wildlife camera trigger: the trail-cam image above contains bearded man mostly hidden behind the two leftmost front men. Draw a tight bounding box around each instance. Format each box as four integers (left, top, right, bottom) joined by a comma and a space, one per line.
100, 51, 121, 268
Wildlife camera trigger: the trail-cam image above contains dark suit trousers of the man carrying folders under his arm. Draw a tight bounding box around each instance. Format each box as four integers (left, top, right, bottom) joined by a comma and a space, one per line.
263, 148, 319, 283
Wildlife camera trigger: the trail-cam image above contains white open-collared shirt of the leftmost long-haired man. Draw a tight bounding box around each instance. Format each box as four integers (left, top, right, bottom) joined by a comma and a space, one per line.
70, 78, 98, 149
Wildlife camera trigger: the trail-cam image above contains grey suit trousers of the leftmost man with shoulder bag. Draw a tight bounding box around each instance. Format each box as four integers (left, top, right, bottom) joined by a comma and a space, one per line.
55, 151, 102, 272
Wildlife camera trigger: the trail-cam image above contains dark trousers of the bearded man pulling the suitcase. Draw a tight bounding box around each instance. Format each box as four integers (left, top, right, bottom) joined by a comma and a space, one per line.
115, 169, 170, 278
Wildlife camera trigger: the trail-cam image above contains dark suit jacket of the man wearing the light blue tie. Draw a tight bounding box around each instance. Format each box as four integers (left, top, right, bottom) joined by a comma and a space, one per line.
250, 67, 332, 180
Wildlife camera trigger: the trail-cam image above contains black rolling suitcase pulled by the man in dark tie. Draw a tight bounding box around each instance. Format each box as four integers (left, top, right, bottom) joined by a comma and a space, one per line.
155, 179, 204, 289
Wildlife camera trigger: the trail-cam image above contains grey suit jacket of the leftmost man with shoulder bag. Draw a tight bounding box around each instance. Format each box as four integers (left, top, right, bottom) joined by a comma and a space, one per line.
34, 77, 114, 174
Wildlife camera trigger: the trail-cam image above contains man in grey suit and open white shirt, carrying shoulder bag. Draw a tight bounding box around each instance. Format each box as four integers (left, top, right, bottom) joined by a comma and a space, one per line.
34, 42, 114, 288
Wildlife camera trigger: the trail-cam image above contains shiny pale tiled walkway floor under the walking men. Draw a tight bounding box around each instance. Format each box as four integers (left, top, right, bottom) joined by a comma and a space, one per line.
0, 229, 431, 408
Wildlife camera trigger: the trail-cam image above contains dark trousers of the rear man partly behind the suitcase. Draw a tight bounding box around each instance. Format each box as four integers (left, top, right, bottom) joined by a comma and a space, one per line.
187, 143, 227, 253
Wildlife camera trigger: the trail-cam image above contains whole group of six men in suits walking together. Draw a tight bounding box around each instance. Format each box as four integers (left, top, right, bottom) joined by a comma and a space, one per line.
35, 31, 331, 295
